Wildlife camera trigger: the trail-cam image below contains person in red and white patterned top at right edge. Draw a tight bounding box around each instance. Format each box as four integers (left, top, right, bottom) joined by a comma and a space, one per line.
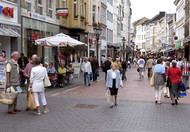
181, 58, 190, 88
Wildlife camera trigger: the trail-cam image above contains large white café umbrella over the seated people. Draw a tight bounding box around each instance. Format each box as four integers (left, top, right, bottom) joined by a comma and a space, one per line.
35, 33, 86, 47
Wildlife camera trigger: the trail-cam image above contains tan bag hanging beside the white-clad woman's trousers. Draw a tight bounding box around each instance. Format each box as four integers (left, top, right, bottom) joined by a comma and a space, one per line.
26, 92, 36, 110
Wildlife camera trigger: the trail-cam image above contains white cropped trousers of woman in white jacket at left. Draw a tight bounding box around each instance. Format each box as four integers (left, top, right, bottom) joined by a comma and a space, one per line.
34, 92, 47, 107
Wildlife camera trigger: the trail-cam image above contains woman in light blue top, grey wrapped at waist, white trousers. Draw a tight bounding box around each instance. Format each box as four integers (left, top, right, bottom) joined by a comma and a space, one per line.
153, 59, 165, 104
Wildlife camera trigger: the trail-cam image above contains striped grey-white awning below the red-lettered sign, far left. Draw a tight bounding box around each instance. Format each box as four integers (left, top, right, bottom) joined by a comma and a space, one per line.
0, 28, 20, 37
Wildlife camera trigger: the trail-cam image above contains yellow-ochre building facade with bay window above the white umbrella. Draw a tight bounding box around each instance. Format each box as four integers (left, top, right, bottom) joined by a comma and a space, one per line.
58, 0, 89, 59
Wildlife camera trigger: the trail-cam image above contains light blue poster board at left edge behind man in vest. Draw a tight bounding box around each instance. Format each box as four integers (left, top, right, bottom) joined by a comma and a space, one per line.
0, 62, 6, 88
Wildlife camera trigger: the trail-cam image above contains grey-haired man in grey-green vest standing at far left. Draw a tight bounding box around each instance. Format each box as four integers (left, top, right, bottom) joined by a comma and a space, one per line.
6, 51, 21, 114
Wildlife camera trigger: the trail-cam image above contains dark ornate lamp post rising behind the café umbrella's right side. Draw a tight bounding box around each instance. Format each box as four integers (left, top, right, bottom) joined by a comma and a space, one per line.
93, 25, 102, 64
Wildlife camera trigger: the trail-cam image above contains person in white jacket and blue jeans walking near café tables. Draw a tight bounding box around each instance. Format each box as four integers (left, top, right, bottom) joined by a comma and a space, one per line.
81, 57, 92, 86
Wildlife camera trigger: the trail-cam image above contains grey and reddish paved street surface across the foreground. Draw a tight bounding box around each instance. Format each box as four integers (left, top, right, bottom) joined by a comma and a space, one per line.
0, 69, 190, 132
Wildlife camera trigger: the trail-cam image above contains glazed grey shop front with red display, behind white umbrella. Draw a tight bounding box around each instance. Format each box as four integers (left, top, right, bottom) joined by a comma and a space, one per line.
22, 16, 59, 63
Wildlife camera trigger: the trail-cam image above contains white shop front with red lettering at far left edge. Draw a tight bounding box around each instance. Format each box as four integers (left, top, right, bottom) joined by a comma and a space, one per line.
0, 1, 21, 59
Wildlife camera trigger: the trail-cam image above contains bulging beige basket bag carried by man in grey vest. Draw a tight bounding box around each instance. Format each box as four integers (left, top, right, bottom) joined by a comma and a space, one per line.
0, 88, 18, 105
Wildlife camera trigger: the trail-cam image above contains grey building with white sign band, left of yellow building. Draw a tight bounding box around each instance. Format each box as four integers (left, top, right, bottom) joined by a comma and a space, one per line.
21, 0, 59, 62
